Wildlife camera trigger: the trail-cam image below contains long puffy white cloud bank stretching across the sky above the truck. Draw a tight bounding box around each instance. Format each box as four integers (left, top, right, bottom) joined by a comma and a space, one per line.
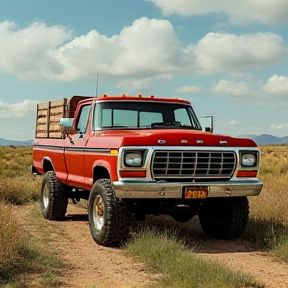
0, 18, 285, 82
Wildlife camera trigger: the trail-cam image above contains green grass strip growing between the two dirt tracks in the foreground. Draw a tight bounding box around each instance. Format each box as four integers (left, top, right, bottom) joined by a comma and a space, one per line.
126, 229, 263, 288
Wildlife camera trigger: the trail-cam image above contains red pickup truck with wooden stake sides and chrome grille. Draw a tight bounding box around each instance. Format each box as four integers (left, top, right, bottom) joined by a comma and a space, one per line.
32, 95, 263, 246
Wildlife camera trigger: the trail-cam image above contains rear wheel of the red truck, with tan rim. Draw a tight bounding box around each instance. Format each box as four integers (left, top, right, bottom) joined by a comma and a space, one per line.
40, 171, 68, 220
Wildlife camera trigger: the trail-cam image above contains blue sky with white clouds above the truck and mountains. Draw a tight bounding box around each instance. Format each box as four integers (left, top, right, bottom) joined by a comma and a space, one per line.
0, 0, 288, 140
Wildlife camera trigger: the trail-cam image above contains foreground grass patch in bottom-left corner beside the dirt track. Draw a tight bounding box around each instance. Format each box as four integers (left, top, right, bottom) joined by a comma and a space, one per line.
0, 202, 61, 288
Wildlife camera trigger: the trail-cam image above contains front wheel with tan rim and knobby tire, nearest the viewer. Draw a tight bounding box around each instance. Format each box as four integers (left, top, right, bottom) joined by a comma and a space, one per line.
88, 179, 131, 246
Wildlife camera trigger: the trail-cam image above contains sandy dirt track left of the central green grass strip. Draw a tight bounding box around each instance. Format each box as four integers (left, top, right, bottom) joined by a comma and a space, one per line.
13, 203, 154, 288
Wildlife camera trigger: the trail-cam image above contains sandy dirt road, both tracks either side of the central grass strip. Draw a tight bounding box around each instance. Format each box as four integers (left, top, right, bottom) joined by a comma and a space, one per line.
14, 204, 288, 288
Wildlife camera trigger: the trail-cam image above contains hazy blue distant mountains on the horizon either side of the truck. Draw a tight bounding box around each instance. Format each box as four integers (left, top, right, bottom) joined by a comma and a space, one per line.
0, 134, 288, 146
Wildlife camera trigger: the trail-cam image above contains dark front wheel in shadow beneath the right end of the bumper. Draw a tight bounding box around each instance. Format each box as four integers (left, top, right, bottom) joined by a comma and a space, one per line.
199, 197, 249, 239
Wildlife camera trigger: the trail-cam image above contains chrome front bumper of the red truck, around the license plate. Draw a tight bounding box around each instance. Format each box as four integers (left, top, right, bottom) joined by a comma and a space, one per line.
113, 178, 263, 199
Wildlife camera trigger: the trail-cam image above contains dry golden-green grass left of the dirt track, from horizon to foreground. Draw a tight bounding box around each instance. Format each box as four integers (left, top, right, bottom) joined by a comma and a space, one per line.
0, 147, 61, 288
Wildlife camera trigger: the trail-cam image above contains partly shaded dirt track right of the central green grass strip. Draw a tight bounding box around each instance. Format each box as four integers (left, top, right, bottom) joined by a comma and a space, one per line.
150, 216, 288, 288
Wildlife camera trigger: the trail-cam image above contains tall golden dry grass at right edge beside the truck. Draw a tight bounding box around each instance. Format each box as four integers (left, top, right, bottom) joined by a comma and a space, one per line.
244, 145, 288, 261
